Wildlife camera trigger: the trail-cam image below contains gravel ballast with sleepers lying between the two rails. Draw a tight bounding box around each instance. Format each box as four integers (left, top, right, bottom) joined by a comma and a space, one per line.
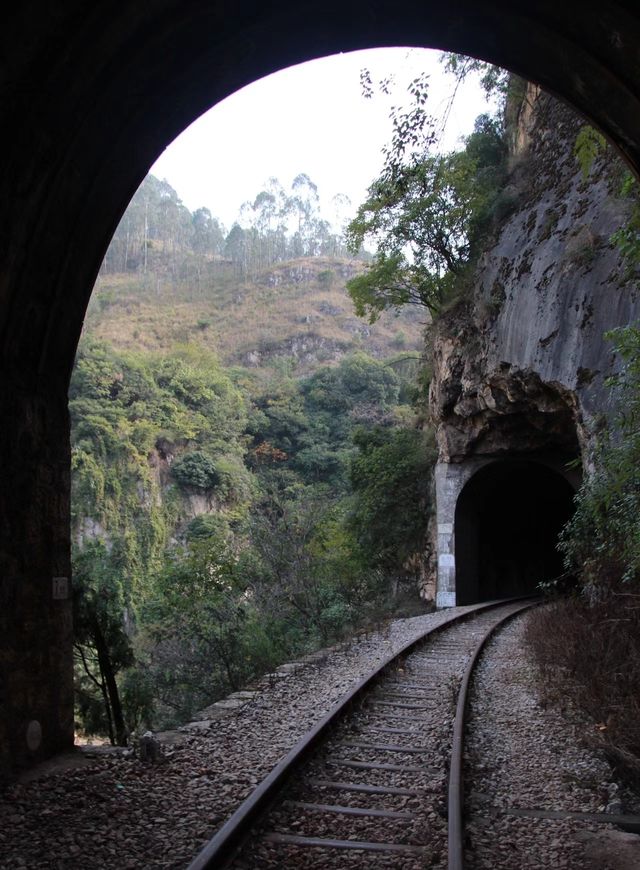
232, 608, 516, 870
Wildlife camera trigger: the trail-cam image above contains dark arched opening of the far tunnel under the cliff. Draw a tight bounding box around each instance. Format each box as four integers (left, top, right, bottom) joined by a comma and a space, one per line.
455, 460, 574, 604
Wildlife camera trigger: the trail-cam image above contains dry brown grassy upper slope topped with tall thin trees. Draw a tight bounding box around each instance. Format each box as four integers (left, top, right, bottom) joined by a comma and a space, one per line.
85, 176, 425, 373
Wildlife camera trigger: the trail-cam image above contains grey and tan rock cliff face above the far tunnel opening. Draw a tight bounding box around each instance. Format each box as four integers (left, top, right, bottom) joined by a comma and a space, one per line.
430, 87, 640, 463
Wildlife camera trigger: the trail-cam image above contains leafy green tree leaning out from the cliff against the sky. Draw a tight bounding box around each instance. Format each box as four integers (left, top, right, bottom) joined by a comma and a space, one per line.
347, 55, 507, 322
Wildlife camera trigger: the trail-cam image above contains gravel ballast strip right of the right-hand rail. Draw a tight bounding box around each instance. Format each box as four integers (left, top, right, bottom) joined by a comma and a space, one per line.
465, 616, 640, 870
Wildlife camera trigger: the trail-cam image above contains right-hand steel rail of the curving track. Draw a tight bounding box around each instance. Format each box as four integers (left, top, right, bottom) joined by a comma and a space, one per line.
447, 601, 538, 870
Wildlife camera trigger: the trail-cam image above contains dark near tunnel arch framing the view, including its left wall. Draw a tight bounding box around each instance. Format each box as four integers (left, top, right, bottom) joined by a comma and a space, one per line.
0, 0, 640, 776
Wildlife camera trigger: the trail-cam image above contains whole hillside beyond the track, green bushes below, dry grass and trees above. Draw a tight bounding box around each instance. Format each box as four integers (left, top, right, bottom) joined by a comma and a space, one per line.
69, 177, 433, 743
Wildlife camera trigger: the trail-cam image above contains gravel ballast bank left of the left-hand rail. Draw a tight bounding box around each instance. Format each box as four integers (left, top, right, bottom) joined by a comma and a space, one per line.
0, 607, 468, 870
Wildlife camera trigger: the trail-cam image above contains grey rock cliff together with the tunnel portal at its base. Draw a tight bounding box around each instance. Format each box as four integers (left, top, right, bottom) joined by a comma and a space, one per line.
422, 86, 640, 606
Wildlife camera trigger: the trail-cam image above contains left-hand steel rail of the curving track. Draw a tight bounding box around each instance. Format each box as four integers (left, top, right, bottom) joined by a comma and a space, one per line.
187, 596, 530, 870
